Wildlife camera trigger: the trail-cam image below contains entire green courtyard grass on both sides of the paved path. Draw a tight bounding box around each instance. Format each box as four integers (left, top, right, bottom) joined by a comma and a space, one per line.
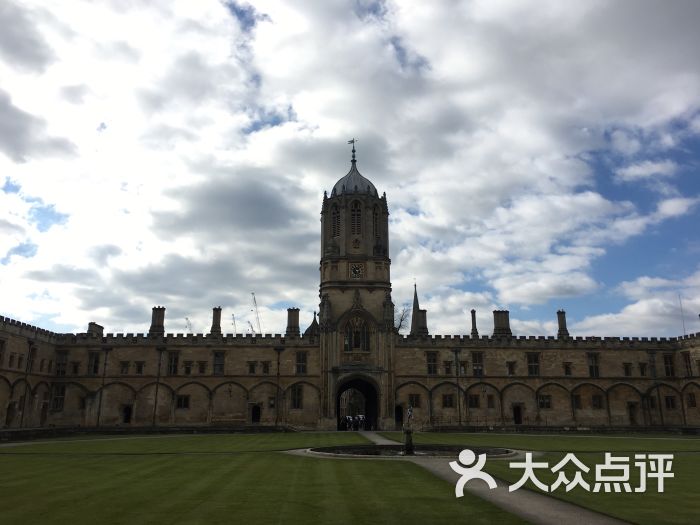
0, 432, 700, 524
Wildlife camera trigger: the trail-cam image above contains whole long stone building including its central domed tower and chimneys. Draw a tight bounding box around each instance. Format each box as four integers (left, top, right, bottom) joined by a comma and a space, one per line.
0, 149, 700, 429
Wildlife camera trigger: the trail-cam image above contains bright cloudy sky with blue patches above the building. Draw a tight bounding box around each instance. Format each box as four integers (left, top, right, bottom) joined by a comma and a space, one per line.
0, 0, 700, 336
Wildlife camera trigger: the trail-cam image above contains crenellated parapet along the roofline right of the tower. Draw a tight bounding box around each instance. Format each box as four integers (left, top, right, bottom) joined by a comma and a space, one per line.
397, 333, 700, 350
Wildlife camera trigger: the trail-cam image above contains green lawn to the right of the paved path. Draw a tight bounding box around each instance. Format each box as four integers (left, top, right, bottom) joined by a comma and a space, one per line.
383, 432, 700, 525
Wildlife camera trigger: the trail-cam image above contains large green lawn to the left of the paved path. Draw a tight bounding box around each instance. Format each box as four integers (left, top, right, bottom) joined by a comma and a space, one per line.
0, 433, 522, 524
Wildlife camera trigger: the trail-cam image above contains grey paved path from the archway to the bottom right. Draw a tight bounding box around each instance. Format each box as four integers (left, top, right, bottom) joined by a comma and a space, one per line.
344, 432, 627, 525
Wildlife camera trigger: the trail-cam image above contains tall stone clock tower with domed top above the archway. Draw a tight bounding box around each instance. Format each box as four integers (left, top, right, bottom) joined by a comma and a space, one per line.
319, 143, 394, 427
